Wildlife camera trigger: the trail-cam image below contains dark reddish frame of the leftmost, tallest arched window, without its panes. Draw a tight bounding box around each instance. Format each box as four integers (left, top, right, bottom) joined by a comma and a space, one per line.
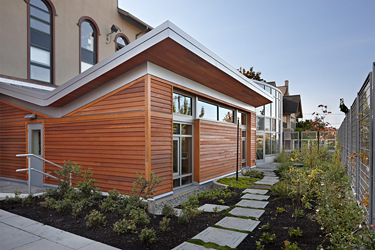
24, 0, 57, 85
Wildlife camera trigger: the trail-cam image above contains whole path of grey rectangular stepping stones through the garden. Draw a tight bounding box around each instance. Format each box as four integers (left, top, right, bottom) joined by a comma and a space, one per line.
172, 163, 279, 250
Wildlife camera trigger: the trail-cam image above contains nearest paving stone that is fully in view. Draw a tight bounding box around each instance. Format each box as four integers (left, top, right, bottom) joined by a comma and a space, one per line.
193, 227, 248, 248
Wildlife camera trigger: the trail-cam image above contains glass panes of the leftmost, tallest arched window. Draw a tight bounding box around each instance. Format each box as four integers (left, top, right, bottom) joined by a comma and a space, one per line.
29, 0, 55, 83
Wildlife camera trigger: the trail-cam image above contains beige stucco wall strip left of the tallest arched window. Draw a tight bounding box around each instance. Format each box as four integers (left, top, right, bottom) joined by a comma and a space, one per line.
0, 0, 27, 79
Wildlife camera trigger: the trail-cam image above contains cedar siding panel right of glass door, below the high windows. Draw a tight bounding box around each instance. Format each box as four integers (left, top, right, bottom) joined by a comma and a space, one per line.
200, 120, 241, 182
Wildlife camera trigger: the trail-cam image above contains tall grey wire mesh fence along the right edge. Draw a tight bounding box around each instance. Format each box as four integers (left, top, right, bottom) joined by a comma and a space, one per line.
338, 63, 375, 228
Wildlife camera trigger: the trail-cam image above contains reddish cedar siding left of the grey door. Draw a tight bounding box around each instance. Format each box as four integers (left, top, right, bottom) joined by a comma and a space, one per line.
0, 123, 27, 180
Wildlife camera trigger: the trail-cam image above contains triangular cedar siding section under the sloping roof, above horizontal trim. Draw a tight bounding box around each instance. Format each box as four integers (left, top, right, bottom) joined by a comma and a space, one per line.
74, 77, 145, 116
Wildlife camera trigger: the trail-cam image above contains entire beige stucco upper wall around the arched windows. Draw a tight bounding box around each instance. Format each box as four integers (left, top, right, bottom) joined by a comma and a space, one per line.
0, 0, 143, 85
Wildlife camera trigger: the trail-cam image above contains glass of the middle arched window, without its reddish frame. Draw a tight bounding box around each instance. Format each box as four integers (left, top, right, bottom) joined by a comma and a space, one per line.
81, 20, 97, 72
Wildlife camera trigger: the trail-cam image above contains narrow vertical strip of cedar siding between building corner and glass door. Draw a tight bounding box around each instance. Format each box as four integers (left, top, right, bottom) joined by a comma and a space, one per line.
151, 77, 173, 195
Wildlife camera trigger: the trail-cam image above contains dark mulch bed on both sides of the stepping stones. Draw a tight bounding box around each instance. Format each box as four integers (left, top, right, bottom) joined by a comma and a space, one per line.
0, 189, 324, 249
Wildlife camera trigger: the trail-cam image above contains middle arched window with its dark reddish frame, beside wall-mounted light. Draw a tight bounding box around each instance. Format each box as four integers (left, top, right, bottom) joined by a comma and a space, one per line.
78, 17, 100, 73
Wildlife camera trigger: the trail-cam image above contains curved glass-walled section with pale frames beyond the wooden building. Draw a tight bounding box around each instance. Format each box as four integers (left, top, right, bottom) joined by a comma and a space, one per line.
254, 80, 283, 163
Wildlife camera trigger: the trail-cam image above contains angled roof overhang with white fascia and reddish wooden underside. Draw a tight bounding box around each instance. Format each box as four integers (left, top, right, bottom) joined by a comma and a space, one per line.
0, 21, 272, 107
